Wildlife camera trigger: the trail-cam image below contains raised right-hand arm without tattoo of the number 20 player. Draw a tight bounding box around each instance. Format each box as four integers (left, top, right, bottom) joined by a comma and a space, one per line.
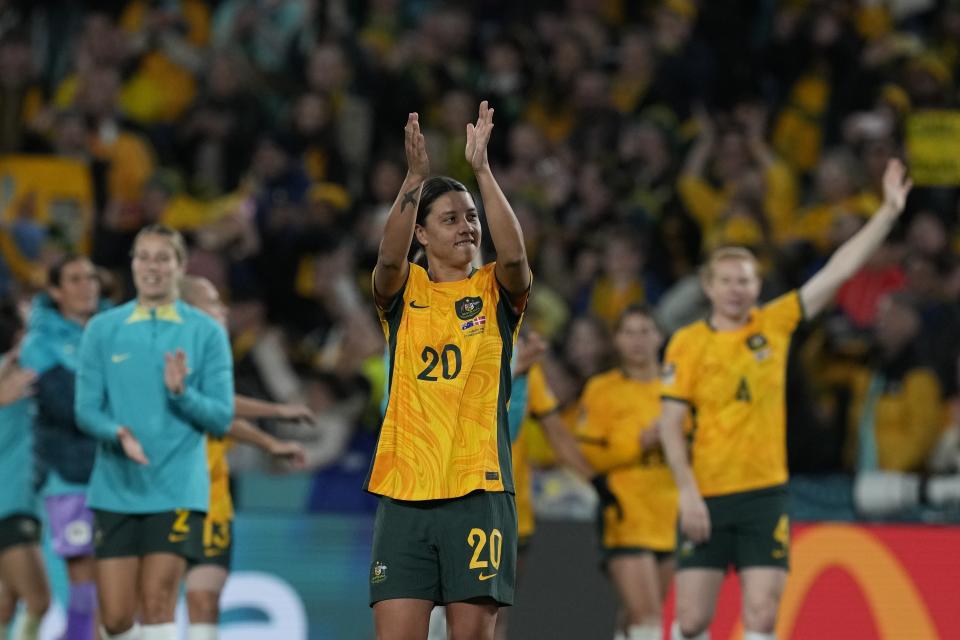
464, 100, 531, 306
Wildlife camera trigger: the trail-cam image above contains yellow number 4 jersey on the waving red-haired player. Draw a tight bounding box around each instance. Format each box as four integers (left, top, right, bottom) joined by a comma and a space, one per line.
662, 291, 803, 496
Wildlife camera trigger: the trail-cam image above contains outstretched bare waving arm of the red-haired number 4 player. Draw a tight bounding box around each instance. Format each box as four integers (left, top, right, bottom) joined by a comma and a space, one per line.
800, 158, 913, 317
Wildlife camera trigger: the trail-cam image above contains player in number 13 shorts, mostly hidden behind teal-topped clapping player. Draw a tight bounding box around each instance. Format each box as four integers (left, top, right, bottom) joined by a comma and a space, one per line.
180, 276, 304, 640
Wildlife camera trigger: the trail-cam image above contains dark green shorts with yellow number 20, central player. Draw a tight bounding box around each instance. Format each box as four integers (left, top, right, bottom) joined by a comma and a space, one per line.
370, 491, 517, 606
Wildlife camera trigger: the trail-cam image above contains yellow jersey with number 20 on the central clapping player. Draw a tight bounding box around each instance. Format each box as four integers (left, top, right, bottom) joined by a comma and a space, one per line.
365, 263, 522, 500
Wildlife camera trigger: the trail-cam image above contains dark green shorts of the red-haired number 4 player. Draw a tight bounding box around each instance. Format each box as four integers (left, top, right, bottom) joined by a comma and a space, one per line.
677, 485, 790, 571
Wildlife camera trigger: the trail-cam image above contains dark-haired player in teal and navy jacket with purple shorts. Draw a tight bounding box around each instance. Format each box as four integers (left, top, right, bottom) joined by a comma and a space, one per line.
20, 255, 101, 640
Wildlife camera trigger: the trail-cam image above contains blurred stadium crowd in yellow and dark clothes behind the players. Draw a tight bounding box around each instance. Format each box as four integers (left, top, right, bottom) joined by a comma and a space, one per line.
0, 0, 960, 496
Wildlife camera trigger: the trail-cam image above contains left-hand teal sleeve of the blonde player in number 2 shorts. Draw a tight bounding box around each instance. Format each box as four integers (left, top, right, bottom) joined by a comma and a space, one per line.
74, 318, 120, 441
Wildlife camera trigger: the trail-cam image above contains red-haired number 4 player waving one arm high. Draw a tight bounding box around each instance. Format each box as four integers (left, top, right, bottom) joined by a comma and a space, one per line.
660, 160, 911, 640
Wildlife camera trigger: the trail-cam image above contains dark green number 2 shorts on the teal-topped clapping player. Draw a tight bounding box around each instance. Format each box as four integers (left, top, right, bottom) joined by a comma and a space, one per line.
93, 509, 203, 561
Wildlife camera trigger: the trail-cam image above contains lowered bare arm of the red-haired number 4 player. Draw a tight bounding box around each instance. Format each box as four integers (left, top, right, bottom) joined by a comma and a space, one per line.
659, 399, 710, 542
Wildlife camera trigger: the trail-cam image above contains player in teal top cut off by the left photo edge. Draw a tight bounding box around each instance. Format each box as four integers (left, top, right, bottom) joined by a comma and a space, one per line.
0, 299, 50, 640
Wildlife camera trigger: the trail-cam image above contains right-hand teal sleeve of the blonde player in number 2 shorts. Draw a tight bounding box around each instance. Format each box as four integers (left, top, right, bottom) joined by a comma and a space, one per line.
167, 320, 234, 436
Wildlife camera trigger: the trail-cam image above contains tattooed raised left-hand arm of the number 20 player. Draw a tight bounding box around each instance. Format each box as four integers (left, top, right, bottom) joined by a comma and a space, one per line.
373, 113, 430, 308
